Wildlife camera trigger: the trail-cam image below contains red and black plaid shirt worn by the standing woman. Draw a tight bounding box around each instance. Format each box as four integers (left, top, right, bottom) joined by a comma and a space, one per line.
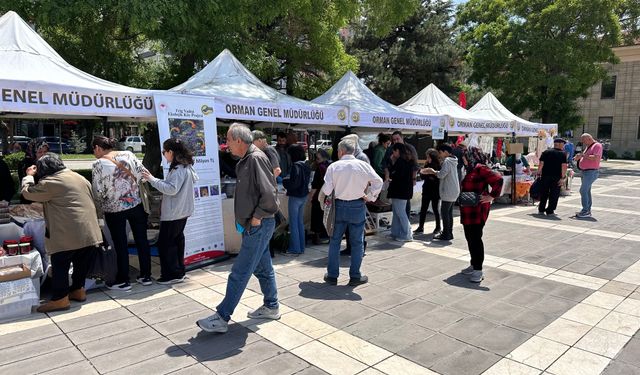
460, 164, 502, 225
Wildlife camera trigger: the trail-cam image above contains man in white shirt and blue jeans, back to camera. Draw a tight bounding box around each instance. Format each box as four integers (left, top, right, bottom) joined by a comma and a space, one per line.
320, 140, 382, 286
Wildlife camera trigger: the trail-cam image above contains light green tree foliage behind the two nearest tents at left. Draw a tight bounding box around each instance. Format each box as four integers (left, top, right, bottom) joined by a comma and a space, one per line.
0, 0, 418, 98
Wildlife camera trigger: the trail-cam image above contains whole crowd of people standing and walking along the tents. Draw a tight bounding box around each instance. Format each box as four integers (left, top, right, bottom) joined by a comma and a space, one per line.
5, 123, 602, 332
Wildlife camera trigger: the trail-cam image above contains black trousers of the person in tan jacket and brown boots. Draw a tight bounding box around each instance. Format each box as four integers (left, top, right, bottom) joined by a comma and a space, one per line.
51, 246, 95, 301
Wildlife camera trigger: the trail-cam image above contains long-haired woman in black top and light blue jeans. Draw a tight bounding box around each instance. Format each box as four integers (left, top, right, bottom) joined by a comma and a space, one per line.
387, 143, 415, 242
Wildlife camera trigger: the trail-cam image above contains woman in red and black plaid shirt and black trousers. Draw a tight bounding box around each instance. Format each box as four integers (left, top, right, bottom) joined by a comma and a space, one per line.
460, 147, 502, 283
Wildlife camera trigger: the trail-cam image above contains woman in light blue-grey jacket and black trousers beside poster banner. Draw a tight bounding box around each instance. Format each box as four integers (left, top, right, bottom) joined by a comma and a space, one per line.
142, 138, 198, 285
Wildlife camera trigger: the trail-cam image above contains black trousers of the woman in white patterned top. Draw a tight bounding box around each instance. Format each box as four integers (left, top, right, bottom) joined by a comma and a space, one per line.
104, 204, 151, 284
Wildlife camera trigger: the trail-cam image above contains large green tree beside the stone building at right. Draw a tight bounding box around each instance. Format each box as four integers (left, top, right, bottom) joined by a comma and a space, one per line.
458, 0, 623, 130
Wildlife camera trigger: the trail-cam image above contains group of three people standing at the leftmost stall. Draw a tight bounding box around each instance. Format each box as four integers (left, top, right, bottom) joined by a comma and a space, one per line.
21, 136, 197, 312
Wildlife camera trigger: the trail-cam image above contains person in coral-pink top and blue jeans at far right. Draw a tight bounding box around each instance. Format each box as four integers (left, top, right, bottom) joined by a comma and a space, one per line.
573, 133, 602, 218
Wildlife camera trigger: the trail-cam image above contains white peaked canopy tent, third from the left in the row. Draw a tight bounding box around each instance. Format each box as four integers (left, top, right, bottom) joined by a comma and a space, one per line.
312, 71, 446, 132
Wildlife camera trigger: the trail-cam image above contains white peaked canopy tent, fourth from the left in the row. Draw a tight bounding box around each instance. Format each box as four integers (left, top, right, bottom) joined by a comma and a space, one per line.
400, 83, 512, 135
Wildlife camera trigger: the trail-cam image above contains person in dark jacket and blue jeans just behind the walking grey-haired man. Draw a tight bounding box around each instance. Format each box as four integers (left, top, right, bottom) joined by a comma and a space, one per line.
282, 145, 311, 256
